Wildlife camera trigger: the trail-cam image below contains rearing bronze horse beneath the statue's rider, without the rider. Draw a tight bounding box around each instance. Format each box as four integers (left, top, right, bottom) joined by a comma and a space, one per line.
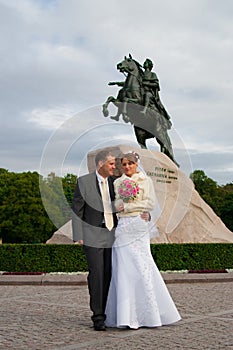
103, 55, 177, 164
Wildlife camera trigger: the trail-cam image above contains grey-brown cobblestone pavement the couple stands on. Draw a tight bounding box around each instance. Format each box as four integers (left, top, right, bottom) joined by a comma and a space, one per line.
0, 281, 233, 350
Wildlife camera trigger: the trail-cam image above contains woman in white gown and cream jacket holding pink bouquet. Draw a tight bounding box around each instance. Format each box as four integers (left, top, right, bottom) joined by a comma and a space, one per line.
105, 153, 181, 329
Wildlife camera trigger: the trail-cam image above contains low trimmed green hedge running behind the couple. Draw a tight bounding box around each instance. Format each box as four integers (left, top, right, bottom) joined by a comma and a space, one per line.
0, 243, 233, 272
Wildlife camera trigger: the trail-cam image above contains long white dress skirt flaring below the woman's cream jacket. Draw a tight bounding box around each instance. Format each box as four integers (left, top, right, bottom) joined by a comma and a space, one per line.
106, 215, 181, 329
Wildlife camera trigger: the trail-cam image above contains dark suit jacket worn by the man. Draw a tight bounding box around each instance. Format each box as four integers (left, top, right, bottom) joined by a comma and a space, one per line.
72, 172, 117, 247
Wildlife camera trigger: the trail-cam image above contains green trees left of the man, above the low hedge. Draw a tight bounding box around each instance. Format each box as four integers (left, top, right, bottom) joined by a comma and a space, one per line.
0, 168, 77, 243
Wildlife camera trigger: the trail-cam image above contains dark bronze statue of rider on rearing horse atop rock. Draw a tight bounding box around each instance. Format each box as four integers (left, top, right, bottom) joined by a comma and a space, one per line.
103, 55, 179, 166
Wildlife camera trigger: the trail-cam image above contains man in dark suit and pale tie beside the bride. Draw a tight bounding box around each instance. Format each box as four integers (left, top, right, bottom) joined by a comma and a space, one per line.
72, 150, 117, 331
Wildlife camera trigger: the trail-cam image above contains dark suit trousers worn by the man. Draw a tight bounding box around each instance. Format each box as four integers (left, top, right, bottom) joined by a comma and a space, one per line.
83, 245, 112, 322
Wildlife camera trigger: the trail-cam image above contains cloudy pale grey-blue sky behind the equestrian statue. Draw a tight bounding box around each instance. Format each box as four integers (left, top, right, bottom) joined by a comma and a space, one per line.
0, 0, 233, 184
